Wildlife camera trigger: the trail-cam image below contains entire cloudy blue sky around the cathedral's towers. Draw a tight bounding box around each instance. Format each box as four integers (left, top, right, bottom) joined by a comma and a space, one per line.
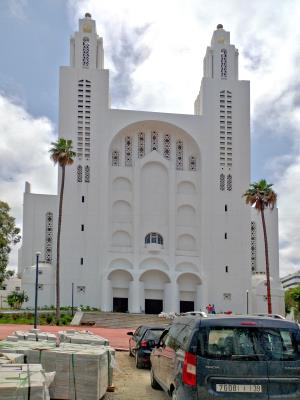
0, 0, 300, 275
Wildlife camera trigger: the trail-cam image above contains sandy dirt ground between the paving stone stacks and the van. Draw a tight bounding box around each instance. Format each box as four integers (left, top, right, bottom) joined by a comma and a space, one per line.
103, 351, 169, 400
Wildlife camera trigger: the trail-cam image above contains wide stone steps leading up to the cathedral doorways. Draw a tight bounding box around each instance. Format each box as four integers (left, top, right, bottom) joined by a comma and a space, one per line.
80, 312, 171, 329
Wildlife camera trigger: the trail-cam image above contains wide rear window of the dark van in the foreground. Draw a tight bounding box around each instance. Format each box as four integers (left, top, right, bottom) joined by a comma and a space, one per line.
198, 327, 300, 361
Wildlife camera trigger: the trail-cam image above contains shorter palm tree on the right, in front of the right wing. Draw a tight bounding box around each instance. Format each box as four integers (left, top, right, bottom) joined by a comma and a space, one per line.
243, 179, 277, 314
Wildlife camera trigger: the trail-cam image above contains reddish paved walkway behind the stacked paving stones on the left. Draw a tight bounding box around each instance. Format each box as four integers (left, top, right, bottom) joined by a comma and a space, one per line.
0, 324, 132, 350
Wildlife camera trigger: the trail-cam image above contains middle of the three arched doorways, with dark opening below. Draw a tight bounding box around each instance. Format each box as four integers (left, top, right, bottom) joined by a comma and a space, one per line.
140, 270, 170, 314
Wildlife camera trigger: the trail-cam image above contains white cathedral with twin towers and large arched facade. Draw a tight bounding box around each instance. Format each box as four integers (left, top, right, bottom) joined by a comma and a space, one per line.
18, 13, 284, 313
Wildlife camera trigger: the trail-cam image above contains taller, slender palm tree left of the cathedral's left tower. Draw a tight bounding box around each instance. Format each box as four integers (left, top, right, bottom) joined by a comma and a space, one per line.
49, 138, 76, 320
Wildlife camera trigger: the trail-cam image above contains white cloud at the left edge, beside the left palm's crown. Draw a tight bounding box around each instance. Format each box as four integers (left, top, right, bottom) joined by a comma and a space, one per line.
0, 94, 56, 266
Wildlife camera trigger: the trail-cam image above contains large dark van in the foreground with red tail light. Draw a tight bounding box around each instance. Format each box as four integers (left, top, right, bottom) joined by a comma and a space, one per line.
151, 316, 300, 400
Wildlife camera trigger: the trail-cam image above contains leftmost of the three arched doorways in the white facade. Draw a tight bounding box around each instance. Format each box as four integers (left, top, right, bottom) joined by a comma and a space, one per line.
108, 270, 133, 312
